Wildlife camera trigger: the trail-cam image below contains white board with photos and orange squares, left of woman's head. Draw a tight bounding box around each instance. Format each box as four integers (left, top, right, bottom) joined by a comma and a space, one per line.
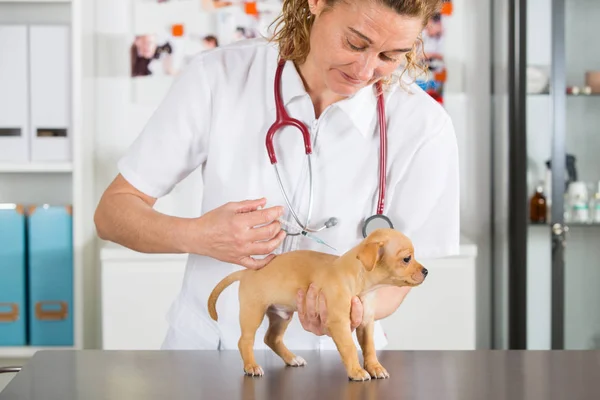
128, 0, 281, 105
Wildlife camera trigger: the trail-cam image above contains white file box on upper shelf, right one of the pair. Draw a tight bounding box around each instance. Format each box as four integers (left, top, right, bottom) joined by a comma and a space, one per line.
29, 25, 71, 162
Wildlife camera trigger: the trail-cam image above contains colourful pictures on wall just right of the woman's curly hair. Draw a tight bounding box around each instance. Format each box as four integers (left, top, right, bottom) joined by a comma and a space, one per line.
417, 0, 453, 104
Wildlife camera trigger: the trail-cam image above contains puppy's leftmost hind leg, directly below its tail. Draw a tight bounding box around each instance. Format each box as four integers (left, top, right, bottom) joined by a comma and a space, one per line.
238, 301, 266, 376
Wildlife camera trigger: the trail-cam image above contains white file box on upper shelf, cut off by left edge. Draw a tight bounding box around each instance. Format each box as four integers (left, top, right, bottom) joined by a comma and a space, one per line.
0, 25, 29, 162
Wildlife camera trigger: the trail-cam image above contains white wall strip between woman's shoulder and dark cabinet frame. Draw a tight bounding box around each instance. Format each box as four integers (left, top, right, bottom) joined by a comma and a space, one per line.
445, 0, 492, 348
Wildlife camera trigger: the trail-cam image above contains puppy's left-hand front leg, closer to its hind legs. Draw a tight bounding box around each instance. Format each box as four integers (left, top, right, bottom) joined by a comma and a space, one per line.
327, 314, 371, 381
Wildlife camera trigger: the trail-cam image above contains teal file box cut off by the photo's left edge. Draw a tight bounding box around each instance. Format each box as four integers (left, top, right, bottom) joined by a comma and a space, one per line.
0, 204, 27, 346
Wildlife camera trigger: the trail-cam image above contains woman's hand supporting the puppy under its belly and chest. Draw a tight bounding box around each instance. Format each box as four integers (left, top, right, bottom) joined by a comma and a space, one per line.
296, 284, 363, 336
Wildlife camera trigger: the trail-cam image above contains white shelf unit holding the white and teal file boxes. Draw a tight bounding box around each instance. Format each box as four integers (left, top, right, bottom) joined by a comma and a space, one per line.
0, 0, 97, 359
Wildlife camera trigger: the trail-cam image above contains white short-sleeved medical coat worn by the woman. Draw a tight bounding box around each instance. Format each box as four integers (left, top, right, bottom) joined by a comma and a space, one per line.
118, 39, 459, 350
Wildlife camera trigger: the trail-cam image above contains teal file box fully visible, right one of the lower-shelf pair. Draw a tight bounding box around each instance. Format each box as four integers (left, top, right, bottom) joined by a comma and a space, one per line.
27, 205, 73, 346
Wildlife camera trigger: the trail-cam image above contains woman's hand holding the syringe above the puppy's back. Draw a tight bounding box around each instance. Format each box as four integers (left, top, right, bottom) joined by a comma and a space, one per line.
187, 198, 285, 269
